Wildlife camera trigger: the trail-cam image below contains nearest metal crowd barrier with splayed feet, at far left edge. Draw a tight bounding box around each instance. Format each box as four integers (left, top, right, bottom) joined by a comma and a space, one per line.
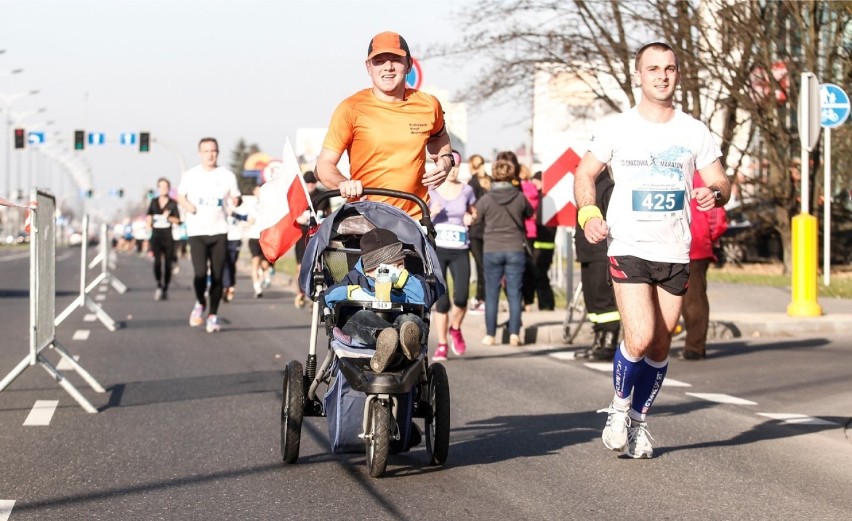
0, 190, 106, 413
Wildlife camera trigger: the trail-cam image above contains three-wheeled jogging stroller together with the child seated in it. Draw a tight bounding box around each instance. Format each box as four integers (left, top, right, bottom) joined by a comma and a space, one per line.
281, 189, 450, 477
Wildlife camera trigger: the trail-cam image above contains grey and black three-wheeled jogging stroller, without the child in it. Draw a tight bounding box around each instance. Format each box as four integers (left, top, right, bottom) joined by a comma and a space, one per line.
281, 189, 450, 477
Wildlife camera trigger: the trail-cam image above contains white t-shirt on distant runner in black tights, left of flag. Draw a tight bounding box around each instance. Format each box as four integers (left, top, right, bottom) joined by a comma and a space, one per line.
178, 165, 240, 237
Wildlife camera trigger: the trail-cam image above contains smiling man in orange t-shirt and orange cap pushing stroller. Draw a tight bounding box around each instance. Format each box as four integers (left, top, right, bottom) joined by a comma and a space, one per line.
316, 32, 455, 218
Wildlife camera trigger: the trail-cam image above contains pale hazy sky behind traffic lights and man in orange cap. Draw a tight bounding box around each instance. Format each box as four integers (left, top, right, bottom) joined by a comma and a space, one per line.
0, 0, 529, 221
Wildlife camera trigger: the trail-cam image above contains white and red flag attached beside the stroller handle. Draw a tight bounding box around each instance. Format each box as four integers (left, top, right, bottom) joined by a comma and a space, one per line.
257, 139, 313, 262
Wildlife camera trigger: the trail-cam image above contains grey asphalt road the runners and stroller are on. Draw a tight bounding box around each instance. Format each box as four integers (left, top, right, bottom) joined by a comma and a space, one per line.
0, 249, 852, 521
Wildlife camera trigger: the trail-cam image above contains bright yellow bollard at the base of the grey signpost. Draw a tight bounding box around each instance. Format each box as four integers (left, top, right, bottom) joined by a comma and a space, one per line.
787, 213, 822, 317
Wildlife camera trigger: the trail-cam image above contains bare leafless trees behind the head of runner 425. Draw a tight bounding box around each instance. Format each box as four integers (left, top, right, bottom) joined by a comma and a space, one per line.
427, 0, 852, 269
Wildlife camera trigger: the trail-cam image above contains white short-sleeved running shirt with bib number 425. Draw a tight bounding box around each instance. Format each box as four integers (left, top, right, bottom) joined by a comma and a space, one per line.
589, 107, 722, 264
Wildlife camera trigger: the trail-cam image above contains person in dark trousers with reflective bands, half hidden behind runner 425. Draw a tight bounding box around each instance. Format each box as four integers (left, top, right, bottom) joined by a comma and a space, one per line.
574, 170, 621, 361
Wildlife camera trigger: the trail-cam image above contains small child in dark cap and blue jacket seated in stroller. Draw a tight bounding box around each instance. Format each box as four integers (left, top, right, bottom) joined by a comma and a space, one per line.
323, 228, 437, 373
